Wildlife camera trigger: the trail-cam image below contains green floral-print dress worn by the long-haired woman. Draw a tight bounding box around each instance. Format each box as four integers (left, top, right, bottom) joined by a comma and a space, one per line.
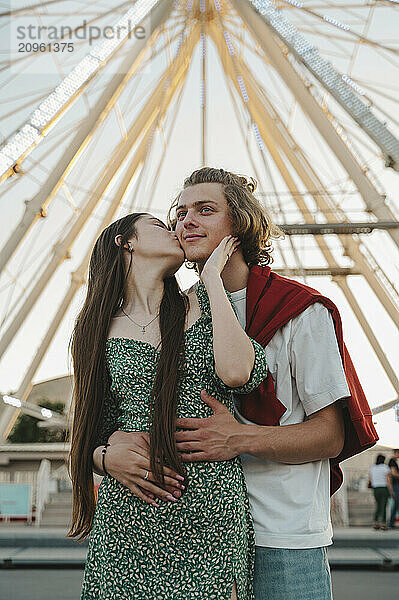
80, 281, 267, 600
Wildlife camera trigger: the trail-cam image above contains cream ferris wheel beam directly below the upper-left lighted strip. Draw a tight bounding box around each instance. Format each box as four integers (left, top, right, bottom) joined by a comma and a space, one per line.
0, 0, 172, 273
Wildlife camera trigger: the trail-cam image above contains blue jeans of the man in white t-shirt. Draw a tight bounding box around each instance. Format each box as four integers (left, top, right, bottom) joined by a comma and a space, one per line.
254, 546, 332, 600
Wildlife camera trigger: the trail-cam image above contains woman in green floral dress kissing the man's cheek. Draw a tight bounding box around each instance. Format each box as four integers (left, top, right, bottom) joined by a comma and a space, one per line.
68, 213, 267, 600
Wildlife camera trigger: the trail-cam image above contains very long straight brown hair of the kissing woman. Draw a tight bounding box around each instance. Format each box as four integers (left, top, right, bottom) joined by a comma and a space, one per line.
67, 213, 188, 541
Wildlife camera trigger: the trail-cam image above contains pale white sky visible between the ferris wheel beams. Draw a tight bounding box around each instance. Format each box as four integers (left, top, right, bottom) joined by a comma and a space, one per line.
0, 2, 399, 446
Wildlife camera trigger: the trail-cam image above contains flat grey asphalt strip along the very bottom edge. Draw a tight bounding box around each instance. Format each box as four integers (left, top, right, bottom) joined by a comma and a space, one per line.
0, 569, 399, 600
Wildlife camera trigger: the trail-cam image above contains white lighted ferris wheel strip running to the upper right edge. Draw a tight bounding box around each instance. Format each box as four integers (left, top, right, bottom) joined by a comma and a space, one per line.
248, 0, 399, 170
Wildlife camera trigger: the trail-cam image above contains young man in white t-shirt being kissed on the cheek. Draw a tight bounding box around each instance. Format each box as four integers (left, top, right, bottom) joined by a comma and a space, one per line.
94, 168, 376, 600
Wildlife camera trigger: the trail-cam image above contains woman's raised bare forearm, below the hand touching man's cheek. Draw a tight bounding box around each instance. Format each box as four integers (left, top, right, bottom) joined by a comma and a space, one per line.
203, 271, 255, 387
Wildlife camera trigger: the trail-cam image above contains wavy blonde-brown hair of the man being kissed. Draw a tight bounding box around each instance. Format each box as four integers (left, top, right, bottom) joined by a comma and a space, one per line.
167, 167, 284, 272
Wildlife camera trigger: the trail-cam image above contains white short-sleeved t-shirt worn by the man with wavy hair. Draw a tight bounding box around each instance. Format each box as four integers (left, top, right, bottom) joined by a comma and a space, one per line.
231, 288, 350, 549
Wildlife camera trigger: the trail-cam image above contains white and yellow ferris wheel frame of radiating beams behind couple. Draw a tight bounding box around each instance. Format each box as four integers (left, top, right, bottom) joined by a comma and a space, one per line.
0, 0, 399, 437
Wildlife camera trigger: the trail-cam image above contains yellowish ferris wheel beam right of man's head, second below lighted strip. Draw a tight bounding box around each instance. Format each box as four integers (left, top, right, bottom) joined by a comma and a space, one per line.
210, 26, 399, 325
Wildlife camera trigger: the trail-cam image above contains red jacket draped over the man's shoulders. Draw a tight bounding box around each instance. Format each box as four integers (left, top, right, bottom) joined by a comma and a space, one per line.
240, 265, 378, 495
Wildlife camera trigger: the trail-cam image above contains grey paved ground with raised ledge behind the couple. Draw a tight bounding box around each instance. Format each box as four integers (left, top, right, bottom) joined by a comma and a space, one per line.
0, 525, 399, 600
